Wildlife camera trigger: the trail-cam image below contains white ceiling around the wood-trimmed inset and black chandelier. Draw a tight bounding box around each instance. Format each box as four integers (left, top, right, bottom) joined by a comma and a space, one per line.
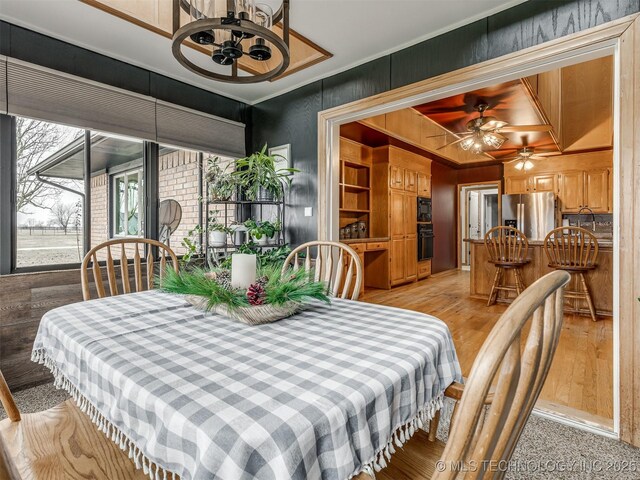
0, 0, 524, 103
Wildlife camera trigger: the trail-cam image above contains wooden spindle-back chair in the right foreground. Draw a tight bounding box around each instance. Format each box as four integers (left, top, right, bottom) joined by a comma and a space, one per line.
356, 271, 571, 480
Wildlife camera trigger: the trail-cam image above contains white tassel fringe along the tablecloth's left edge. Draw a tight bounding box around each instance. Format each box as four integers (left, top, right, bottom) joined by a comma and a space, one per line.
31, 348, 180, 480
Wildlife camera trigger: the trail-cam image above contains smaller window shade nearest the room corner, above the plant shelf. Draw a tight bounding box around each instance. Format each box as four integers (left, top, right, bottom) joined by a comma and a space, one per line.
156, 100, 245, 157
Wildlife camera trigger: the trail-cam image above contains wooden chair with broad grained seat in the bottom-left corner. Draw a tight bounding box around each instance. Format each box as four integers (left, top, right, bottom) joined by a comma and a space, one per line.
0, 372, 149, 480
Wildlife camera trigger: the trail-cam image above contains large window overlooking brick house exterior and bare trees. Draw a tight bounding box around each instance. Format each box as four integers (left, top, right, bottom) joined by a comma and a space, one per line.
0, 110, 236, 273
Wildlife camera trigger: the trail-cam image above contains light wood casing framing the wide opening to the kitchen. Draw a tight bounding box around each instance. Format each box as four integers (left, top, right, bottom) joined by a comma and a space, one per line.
318, 15, 640, 444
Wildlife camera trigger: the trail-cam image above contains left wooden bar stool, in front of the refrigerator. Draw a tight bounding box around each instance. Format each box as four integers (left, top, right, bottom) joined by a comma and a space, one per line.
484, 227, 530, 307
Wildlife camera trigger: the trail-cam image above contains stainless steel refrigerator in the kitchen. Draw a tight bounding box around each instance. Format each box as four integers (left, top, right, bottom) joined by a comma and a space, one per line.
502, 192, 556, 240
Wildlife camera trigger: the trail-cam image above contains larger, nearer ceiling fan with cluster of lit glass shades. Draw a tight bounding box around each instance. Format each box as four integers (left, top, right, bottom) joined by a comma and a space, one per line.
435, 103, 553, 153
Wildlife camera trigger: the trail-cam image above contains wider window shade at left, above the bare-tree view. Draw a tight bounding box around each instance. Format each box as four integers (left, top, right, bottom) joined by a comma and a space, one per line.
6, 58, 156, 140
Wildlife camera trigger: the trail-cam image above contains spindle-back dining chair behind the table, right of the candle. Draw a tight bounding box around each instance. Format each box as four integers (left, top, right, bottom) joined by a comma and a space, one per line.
282, 240, 363, 300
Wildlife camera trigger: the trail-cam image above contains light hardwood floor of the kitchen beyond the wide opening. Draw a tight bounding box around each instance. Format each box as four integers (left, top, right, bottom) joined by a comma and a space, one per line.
361, 270, 613, 428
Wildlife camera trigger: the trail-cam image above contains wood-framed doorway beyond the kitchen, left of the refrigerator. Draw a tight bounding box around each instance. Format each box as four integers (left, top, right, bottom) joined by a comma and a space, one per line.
458, 182, 501, 270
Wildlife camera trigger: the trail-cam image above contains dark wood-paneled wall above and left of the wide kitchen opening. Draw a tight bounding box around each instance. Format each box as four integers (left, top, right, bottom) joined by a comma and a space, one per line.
247, 0, 640, 244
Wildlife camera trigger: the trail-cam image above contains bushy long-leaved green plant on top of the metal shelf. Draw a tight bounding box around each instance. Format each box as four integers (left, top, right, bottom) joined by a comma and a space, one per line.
231, 144, 299, 201
